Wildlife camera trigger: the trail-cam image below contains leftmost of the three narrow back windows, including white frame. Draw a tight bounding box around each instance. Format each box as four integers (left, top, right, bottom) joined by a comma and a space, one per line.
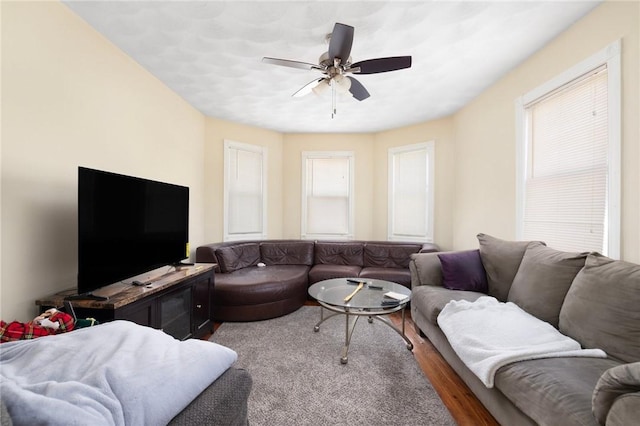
224, 141, 267, 241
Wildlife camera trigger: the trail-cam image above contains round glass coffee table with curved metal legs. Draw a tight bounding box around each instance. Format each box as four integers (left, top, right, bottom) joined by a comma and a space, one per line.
309, 278, 413, 364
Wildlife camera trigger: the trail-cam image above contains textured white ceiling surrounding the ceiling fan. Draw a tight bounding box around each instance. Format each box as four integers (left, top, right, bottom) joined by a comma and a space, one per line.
65, 1, 599, 133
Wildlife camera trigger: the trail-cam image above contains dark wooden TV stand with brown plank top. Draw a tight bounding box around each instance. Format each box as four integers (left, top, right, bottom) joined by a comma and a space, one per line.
36, 263, 216, 340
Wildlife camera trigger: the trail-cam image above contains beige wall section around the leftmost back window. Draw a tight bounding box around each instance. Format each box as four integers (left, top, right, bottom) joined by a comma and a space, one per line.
204, 118, 283, 243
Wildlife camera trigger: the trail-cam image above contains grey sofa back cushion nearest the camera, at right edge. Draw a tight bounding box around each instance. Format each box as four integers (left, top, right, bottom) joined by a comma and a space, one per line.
560, 254, 640, 362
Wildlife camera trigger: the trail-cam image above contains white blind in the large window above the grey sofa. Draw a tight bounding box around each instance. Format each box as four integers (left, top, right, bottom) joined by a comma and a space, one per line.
523, 67, 608, 252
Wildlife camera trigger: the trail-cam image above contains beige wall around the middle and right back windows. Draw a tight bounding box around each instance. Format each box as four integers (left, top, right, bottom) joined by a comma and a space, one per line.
283, 118, 453, 247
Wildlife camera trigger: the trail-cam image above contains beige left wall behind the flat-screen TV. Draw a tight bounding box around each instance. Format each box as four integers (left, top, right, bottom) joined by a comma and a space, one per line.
0, 2, 205, 321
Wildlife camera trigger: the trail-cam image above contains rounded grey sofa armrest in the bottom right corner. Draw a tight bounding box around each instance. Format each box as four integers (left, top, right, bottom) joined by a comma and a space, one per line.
592, 362, 640, 425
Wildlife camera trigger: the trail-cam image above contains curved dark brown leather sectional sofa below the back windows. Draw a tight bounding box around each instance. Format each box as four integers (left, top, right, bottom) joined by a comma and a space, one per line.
196, 240, 438, 321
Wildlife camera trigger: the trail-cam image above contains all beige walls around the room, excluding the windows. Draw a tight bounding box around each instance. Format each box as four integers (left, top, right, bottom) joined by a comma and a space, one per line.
0, 2, 640, 321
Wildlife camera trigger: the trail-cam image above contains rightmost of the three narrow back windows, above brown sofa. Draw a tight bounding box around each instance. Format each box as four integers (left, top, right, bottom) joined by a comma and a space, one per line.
388, 141, 434, 242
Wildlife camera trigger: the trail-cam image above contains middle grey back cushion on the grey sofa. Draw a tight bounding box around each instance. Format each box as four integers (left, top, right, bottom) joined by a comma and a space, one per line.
507, 244, 587, 328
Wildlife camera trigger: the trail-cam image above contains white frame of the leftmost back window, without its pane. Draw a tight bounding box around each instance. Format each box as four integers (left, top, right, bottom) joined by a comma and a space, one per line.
223, 140, 267, 241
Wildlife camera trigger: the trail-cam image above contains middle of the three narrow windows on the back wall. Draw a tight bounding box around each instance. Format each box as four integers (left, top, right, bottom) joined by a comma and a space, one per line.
301, 151, 353, 239
